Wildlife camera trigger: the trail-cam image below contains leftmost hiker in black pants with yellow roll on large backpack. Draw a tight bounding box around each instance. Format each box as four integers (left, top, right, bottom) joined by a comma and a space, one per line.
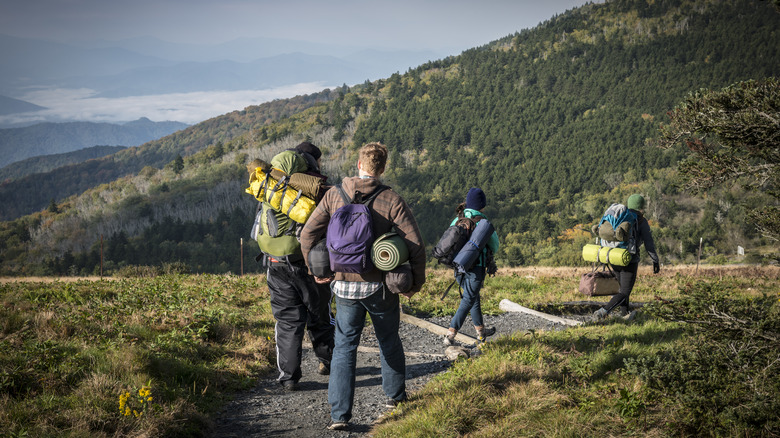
246, 142, 335, 391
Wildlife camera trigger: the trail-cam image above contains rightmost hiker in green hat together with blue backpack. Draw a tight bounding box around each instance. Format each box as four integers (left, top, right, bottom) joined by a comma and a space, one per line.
593, 194, 661, 320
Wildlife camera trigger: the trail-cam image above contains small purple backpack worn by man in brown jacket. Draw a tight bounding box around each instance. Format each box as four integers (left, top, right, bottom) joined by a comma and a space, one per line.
326, 184, 389, 274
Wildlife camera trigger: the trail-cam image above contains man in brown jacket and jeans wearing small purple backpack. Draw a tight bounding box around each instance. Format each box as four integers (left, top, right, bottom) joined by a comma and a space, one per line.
301, 143, 425, 430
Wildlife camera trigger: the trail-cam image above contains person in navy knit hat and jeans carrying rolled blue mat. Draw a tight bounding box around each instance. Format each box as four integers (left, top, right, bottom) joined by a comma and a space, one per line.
444, 187, 498, 345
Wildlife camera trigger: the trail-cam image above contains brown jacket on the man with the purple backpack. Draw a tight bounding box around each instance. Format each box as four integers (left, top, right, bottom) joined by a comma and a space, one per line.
301, 177, 425, 292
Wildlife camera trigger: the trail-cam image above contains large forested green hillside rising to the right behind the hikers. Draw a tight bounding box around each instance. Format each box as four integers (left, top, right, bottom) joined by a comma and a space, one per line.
0, 0, 780, 274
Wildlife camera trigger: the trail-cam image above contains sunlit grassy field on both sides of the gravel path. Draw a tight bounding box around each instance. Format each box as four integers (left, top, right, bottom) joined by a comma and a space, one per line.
0, 266, 780, 437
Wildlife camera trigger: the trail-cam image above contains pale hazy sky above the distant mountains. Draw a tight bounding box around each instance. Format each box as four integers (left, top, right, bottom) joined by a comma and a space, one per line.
0, 0, 587, 53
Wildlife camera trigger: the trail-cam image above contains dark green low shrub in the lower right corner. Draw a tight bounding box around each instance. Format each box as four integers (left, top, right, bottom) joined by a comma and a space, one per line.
626, 283, 780, 436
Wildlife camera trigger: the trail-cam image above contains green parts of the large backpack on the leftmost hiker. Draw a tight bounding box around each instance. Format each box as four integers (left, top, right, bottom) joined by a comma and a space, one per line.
251, 150, 308, 261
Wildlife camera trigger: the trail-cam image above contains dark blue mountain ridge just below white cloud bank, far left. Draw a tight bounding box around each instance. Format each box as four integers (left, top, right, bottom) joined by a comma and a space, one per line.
0, 118, 188, 167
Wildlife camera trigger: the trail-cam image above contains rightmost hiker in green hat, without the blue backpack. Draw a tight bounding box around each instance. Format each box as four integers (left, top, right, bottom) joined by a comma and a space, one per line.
593, 194, 661, 321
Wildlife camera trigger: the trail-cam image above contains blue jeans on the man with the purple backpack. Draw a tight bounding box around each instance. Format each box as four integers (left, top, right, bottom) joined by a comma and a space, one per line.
328, 289, 406, 422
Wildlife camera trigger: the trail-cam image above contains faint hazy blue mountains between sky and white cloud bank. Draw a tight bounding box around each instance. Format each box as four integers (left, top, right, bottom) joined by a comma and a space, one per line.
0, 34, 445, 115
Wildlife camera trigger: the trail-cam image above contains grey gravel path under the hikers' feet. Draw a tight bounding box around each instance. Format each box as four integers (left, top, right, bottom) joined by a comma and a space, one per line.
213, 312, 580, 438
